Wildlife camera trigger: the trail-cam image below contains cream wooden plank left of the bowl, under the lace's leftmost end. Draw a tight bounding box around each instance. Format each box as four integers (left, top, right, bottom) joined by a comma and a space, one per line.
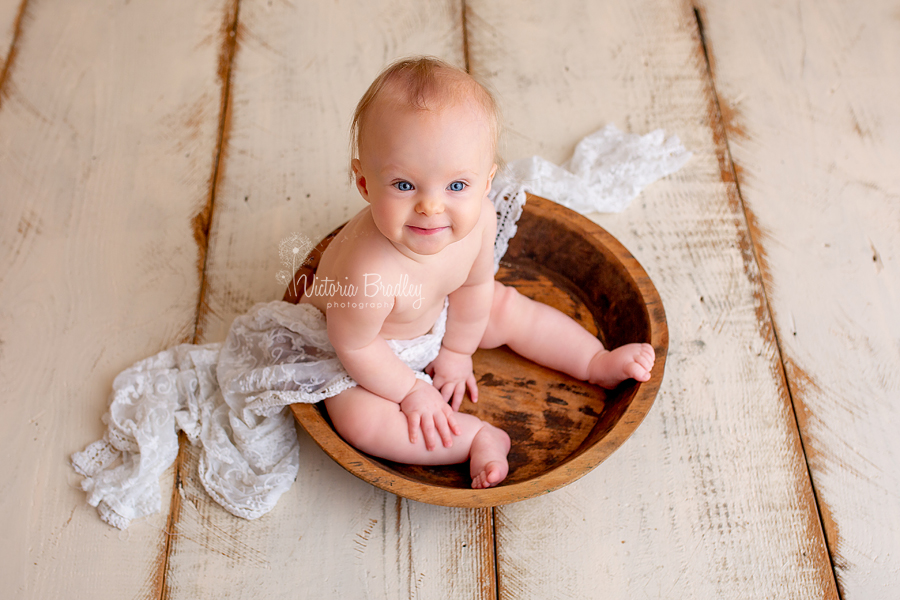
0, 0, 236, 598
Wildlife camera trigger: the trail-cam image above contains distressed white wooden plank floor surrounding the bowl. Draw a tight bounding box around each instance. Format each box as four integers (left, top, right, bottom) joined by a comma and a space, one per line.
0, 0, 900, 600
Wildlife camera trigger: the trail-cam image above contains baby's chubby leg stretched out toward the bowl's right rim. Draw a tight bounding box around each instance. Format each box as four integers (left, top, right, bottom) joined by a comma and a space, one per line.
480, 282, 654, 388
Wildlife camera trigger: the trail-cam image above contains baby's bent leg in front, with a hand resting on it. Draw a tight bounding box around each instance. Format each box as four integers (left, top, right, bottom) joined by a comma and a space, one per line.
325, 386, 509, 488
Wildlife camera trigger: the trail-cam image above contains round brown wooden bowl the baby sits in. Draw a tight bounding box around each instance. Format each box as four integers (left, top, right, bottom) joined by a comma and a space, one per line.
284, 196, 669, 507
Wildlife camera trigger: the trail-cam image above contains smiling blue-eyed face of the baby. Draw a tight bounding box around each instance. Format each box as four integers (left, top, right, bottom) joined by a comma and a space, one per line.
353, 96, 496, 256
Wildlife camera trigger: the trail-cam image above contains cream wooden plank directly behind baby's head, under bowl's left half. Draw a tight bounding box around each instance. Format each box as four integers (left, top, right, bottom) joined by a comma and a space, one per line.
164, 0, 495, 599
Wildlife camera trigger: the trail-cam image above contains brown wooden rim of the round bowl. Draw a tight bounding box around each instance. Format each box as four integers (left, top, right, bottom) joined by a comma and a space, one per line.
285, 194, 669, 508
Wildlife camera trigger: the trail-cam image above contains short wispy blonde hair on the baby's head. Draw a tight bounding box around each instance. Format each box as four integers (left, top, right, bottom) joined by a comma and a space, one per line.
350, 56, 500, 179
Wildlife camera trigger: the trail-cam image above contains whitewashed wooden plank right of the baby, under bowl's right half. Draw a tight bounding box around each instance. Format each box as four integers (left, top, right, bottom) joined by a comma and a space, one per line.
467, 0, 836, 600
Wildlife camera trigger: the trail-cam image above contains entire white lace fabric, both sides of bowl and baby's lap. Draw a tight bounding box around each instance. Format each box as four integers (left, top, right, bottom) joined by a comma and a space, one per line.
72, 126, 690, 529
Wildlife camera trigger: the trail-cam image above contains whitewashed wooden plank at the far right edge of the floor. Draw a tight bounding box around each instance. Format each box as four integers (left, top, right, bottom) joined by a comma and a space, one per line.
703, 0, 900, 600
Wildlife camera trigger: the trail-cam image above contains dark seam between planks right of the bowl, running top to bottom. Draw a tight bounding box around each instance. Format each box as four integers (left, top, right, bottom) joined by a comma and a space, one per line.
690, 3, 843, 600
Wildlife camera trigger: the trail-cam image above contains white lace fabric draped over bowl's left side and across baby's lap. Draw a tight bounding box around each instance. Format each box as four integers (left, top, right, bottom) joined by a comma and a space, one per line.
72, 301, 447, 529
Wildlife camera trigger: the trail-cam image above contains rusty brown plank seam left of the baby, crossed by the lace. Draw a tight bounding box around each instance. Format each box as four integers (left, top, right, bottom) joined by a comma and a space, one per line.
158, 0, 240, 600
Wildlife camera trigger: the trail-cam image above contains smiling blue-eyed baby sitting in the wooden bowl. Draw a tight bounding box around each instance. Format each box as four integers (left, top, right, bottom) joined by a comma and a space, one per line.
302, 58, 654, 488
